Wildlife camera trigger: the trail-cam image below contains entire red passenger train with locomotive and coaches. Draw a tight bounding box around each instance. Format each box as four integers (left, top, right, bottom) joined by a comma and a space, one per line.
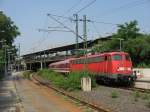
49, 52, 136, 83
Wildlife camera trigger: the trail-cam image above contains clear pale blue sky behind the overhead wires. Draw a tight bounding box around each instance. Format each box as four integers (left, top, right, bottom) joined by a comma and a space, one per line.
0, 0, 150, 55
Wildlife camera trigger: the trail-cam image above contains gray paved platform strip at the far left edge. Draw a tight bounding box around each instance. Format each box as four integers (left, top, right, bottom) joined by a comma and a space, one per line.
0, 76, 22, 112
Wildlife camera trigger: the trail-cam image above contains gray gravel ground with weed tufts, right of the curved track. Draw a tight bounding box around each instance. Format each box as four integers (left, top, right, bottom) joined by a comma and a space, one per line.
70, 85, 150, 112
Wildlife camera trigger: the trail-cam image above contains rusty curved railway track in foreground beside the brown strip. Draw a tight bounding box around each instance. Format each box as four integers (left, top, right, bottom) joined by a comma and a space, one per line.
32, 75, 112, 112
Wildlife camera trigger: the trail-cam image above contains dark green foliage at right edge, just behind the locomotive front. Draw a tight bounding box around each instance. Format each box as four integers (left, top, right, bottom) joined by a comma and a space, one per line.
124, 35, 150, 67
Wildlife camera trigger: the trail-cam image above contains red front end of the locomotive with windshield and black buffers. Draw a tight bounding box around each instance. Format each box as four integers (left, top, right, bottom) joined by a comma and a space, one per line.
112, 52, 136, 82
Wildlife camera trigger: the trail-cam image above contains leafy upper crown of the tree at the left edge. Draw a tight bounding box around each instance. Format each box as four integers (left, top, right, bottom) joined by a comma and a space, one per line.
0, 11, 20, 46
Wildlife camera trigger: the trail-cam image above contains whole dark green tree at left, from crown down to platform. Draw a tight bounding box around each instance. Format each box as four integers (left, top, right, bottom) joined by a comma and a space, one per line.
0, 11, 20, 77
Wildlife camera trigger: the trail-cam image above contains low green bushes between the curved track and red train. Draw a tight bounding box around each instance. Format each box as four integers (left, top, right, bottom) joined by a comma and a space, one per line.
37, 69, 96, 91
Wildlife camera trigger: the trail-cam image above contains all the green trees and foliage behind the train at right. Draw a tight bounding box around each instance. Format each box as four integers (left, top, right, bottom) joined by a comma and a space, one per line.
92, 21, 150, 67
